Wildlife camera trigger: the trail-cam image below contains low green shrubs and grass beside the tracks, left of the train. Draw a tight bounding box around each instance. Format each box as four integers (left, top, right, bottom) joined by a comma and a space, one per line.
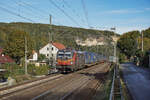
0, 64, 50, 83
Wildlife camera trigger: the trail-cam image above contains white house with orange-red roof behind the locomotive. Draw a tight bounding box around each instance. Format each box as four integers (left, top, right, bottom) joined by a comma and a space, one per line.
39, 42, 65, 65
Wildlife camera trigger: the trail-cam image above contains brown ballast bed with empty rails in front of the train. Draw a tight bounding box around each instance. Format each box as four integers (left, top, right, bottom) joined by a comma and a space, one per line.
1, 64, 109, 100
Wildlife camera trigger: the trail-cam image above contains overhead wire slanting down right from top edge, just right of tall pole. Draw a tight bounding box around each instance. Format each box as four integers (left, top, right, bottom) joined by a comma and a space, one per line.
49, 0, 80, 26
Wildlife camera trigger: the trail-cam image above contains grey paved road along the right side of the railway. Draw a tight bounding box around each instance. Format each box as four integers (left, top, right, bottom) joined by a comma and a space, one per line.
121, 63, 150, 100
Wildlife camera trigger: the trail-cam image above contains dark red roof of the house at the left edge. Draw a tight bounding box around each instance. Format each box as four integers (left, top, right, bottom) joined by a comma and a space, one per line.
0, 48, 14, 64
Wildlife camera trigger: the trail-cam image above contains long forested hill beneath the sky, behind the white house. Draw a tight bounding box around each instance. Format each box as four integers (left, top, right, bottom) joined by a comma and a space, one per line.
0, 22, 118, 50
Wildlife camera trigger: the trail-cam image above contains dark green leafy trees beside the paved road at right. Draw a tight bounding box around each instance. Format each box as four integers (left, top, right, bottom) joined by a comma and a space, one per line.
117, 28, 150, 67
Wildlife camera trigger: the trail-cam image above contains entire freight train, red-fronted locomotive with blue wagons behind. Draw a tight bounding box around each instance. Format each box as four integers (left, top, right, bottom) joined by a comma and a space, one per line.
56, 49, 107, 73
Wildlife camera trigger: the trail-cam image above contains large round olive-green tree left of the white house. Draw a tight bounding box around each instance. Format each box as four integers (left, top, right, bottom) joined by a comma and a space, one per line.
4, 30, 33, 64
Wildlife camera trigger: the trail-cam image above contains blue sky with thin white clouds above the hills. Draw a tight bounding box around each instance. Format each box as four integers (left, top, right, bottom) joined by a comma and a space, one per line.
0, 0, 150, 34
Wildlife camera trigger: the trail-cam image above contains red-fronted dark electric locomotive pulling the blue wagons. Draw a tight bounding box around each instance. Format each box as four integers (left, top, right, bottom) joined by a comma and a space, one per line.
56, 49, 85, 72
